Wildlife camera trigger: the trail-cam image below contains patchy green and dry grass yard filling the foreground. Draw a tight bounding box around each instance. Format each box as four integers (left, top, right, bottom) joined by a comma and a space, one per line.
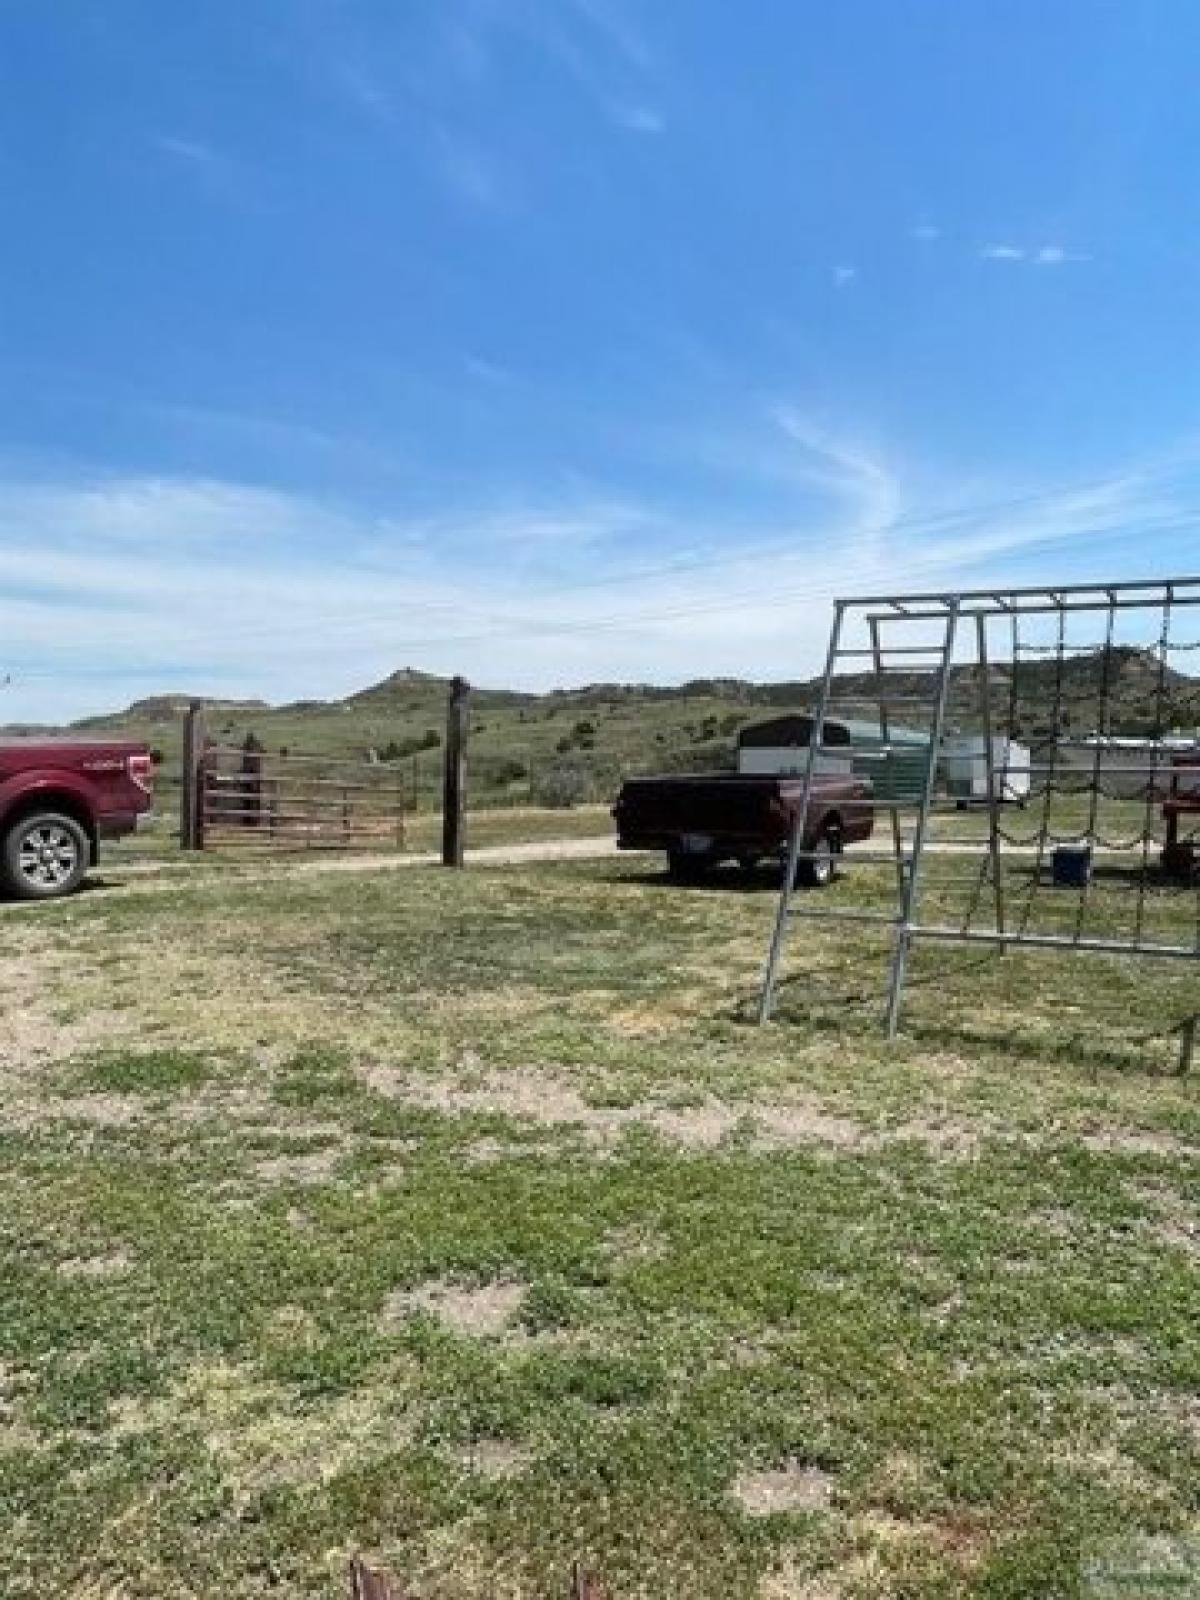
0, 858, 1200, 1600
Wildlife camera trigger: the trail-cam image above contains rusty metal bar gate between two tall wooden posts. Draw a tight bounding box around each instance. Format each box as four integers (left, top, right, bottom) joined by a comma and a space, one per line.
195, 739, 410, 850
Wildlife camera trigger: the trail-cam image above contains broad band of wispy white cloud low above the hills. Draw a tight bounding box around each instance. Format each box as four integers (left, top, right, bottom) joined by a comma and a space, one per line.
0, 425, 1200, 722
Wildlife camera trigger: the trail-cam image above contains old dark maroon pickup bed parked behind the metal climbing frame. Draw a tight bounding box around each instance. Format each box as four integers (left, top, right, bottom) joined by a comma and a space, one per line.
613, 773, 874, 888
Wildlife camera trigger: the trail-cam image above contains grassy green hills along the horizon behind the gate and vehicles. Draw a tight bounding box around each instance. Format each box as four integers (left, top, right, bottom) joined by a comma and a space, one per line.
7, 648, 1200, 800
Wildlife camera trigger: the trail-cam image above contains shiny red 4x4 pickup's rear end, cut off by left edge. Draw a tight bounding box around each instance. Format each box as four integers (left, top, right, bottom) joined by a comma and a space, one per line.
0, 736, 154, 899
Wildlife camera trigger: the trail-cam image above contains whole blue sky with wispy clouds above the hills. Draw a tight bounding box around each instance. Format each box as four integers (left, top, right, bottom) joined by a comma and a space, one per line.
0, 0, 1200, 720
